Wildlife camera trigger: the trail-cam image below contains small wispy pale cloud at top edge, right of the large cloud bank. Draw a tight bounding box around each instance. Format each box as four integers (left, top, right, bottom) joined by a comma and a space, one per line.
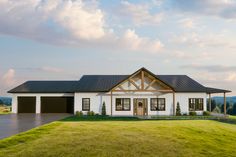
120, 1, 164, 26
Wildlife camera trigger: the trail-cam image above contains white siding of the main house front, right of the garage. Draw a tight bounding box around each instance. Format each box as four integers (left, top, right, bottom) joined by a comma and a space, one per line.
74, 93, 207, 116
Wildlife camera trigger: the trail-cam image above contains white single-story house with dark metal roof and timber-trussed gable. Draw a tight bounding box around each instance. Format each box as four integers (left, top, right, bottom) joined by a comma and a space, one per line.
9, 68, 230, 116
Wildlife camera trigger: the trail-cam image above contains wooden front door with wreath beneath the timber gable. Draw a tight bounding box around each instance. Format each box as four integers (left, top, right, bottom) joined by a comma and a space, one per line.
134, 99, 147, 116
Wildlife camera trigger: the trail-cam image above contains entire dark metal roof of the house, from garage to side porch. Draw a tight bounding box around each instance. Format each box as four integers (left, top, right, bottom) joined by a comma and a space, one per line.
8, 68, 230, 93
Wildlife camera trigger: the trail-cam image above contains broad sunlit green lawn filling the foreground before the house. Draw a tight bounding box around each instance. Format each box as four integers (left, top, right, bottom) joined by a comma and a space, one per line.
0, 119, 236, 157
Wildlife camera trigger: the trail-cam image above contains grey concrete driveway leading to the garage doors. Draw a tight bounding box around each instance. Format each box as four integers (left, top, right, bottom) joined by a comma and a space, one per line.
0, 113, 72, 139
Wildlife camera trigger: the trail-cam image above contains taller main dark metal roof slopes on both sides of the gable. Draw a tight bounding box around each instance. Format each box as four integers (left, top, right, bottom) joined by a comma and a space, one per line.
76, 75, 206, 92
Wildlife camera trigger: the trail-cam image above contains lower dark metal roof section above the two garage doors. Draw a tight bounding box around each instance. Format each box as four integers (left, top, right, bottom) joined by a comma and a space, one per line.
8, 81, 78, 93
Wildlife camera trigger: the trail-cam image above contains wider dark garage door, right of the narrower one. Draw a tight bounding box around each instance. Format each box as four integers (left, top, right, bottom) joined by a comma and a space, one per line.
41, 97, 74, 113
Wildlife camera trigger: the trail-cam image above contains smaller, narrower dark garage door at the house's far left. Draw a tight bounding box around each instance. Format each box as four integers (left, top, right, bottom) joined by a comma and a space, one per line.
17, 97, 36, 113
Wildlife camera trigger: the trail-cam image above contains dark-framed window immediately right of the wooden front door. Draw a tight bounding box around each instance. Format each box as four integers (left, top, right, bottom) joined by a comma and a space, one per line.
150, 98, 166, 111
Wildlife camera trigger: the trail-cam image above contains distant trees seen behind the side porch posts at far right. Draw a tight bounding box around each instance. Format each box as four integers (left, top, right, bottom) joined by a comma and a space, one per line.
207, 99, 236, 115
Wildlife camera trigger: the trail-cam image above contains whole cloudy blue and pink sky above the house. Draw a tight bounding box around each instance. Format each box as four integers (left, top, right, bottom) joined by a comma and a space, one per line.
0, 0, 236, 96
